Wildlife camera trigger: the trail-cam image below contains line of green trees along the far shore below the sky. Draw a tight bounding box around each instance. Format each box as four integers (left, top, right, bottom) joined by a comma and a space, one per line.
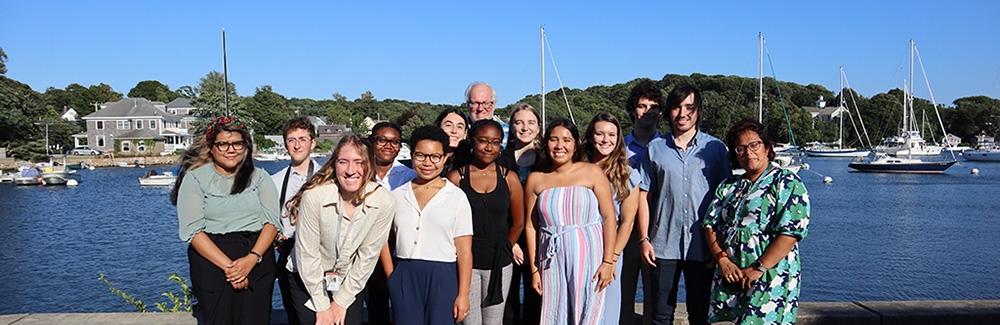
0, 48, 1000, 160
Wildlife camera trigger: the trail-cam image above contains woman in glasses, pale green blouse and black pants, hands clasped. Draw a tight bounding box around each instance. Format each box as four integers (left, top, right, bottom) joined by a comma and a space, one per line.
170, 116, 281, 324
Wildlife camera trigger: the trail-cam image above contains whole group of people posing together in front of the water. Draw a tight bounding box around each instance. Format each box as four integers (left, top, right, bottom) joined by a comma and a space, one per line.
171, 80, 809, 325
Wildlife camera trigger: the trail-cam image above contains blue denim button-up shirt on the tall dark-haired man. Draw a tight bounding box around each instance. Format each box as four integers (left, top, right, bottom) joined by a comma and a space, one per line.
639, 131, 732, 261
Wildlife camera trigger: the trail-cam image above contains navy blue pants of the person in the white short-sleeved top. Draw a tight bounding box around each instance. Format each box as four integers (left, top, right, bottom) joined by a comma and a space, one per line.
386, 260, 458, 325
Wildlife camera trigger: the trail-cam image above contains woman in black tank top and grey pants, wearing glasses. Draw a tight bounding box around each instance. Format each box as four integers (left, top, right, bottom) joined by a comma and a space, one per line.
448, 120, 524, 324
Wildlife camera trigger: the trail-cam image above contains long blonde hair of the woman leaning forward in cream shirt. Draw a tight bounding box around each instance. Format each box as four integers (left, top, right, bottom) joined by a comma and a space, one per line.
285, 133, 377, 225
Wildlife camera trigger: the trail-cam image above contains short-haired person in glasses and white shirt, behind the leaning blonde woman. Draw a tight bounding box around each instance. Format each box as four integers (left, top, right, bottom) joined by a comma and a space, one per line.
271, 116, 320, 324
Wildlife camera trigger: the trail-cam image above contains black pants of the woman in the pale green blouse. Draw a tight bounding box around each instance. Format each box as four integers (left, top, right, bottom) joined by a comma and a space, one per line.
188, 231, 275, 324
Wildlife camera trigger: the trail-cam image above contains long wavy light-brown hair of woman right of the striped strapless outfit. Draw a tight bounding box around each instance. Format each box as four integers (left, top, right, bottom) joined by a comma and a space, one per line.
583, 112, 632, 202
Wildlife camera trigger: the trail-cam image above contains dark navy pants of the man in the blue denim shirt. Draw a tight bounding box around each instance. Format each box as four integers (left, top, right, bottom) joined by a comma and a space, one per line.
647, 258, 715, 324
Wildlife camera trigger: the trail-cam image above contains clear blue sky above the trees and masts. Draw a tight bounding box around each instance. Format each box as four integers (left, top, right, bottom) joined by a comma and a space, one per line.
0, 0, 1000, 106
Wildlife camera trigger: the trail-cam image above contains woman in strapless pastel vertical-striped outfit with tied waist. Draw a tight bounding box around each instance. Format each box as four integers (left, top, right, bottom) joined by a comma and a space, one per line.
525, 119, 617, 324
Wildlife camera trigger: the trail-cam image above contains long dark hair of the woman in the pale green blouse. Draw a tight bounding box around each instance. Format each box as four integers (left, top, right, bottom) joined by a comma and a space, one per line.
170, 116, 254, 205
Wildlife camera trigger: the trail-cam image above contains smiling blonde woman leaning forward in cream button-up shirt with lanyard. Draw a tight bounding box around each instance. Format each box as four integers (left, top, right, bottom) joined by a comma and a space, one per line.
288, 133, 396, 325
